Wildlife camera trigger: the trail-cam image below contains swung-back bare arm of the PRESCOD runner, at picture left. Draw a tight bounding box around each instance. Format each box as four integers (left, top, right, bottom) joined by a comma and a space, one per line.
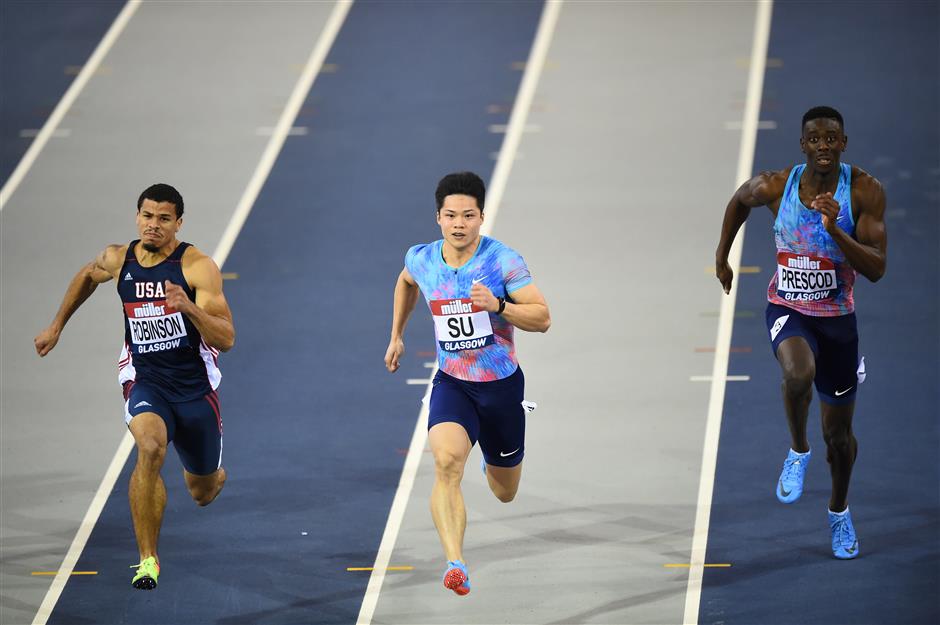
715, 170, 790, 293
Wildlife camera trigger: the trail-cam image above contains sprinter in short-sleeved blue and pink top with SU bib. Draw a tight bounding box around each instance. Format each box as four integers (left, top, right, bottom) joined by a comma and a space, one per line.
385, 172, 551, 595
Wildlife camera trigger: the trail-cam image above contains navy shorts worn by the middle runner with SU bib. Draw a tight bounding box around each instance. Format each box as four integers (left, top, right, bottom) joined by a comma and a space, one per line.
428, 367, 525, 467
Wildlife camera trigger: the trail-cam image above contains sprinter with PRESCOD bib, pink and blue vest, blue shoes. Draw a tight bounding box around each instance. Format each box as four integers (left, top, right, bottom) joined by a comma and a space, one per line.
715, 106, 887, 560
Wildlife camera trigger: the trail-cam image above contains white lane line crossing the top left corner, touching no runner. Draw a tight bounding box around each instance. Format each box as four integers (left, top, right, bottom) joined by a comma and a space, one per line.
0, 0, 141, 211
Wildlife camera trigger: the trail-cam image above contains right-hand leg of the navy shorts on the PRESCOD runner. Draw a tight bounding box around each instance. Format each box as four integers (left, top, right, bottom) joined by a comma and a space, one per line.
816, 314, 858, 406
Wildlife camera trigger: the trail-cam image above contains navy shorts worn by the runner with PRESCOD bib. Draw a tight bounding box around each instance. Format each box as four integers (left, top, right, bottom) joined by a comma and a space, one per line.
767, 303, 860, 406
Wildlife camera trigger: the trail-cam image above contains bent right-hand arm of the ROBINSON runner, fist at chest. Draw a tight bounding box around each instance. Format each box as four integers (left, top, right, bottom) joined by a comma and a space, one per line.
174, 248, 235, 352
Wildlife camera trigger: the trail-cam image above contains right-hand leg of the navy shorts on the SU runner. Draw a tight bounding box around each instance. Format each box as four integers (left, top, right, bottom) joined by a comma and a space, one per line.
474, 368, 525, 467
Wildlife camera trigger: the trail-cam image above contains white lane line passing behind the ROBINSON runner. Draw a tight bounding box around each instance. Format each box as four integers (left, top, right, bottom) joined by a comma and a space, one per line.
33, 0, 352, 625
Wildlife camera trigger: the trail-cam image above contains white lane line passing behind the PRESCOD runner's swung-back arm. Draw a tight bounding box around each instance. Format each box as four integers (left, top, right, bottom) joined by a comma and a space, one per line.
683, 0, 773, 625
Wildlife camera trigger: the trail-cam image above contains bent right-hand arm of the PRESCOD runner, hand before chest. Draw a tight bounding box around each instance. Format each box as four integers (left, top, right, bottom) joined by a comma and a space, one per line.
811, 169, 888, 282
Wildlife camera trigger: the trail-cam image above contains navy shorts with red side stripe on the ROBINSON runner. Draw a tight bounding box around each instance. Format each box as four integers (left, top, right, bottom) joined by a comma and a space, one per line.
124, 382, 222, 475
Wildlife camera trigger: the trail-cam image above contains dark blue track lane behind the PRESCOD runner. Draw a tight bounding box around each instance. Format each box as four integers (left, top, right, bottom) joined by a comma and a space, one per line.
699, 2, 940, 625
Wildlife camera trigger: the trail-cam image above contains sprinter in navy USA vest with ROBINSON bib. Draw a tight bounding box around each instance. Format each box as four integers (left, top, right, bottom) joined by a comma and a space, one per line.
35, 184, 235, 590
